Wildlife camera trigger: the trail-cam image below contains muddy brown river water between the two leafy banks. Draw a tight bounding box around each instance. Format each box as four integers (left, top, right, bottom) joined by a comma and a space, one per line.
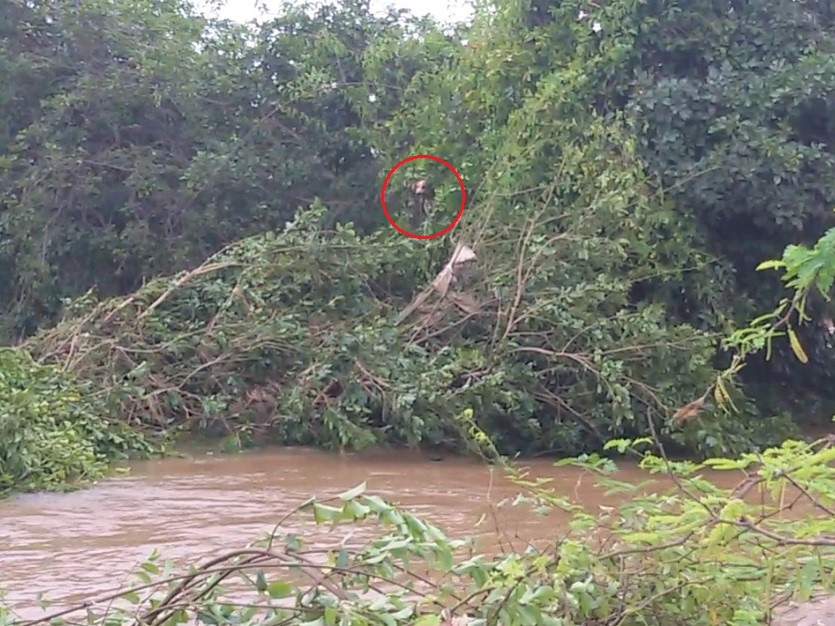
0, 449, 832, 619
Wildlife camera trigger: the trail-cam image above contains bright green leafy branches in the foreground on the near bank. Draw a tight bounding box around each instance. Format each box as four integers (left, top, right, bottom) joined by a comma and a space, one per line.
6, 439, 835, 626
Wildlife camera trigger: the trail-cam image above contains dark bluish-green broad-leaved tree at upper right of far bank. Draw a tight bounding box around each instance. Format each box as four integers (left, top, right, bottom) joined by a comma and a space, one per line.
628, 1, 835, 398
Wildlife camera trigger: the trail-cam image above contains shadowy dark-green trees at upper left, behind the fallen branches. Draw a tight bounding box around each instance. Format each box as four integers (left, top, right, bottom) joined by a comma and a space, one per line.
0, 0, 422, 337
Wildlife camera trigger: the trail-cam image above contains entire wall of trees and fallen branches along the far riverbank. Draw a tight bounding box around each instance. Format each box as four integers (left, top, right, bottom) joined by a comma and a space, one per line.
0, 0, 835, 482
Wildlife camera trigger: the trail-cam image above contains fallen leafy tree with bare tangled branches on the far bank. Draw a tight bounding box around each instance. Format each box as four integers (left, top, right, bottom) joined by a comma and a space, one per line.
25, 122, 796, 454
